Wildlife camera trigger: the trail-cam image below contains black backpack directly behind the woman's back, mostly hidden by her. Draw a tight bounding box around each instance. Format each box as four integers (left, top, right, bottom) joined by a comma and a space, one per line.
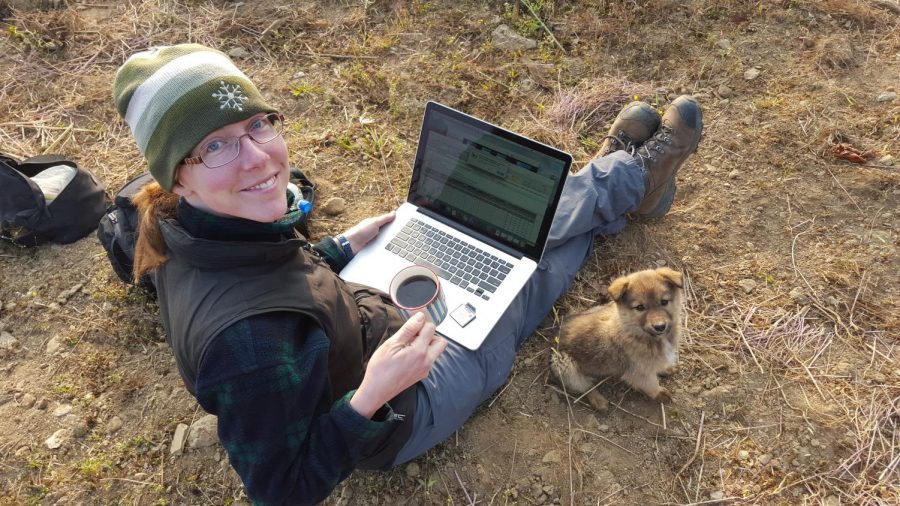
97, 169, 316, 295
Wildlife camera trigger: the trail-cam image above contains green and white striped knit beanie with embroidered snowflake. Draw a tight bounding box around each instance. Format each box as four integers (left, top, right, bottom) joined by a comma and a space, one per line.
113, 44, 275, 191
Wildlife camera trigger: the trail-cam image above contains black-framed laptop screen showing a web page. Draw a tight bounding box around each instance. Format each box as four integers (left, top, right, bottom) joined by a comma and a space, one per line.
407, 102, 572, 259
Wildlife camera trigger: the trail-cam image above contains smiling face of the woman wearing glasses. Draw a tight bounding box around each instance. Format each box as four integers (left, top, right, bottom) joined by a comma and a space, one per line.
172, 114, 290, 223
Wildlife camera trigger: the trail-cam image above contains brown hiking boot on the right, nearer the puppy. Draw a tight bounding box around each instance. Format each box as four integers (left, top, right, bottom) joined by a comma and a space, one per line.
633, 95, 703, 218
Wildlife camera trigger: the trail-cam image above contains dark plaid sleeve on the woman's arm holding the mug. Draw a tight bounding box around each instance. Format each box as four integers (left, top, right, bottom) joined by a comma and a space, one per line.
197, 313, 401, 504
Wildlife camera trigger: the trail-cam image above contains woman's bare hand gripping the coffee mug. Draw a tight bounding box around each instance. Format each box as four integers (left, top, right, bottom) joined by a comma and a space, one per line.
350, 313, 447, 418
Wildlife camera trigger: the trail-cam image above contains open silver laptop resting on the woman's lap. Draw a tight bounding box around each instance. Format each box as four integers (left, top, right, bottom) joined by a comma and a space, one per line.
340, 102, 572, 350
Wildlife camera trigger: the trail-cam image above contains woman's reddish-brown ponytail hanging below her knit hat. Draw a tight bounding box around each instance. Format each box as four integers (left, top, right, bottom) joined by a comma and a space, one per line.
132, 181, 178, 280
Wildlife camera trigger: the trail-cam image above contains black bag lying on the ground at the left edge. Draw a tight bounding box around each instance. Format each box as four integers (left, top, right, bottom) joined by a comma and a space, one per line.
0, 155, 106, 246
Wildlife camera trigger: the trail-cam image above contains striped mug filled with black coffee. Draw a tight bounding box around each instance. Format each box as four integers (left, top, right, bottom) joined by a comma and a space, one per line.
390, 265, 447, 325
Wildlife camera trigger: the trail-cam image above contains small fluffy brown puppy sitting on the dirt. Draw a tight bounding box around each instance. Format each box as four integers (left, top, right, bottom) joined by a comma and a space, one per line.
550, 267, 682, 412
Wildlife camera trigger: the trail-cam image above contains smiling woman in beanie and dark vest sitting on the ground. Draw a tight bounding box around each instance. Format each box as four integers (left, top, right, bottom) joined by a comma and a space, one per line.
113, 44, 702, 504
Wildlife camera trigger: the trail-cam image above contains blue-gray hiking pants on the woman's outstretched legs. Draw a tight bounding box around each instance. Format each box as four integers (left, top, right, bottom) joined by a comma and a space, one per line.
394, 151, 644, 466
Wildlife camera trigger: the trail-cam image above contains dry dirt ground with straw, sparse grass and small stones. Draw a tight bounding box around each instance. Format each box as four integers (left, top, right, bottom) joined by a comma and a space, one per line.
0, 0, 900, 506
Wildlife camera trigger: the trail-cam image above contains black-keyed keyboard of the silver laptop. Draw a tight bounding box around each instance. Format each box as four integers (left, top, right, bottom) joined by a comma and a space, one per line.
385, 218, 513, 300
